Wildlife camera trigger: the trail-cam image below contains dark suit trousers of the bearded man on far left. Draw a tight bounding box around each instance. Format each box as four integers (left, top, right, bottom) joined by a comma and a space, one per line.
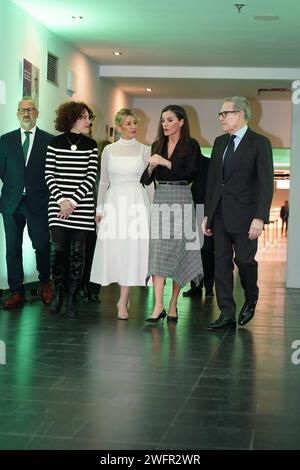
2, 196, 50, 294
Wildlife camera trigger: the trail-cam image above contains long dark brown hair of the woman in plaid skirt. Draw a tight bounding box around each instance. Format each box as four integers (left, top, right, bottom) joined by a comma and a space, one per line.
152, 104, 191, 156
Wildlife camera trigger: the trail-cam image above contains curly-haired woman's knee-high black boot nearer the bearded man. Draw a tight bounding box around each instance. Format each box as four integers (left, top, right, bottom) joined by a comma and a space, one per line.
50, 242, 65, 314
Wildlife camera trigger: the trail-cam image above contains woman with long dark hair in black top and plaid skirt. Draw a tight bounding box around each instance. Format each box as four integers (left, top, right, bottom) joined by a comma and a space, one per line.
141, 105, 203, 323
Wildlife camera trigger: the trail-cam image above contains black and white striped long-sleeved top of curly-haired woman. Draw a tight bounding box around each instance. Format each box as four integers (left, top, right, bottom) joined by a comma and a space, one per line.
45, 133, 98, 231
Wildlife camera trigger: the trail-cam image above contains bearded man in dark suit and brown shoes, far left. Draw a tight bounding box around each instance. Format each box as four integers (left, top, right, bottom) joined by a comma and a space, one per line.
0, 97, 53, 309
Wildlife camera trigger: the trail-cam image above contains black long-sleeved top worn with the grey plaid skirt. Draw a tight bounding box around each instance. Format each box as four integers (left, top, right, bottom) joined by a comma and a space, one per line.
141, 138, 201, 185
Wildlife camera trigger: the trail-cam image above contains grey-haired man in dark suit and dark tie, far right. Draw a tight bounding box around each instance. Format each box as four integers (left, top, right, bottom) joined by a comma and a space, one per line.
203, 96, 273, 330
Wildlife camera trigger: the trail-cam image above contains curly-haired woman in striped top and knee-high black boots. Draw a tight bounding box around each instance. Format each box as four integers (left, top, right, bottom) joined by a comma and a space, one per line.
45, 101, 98, 318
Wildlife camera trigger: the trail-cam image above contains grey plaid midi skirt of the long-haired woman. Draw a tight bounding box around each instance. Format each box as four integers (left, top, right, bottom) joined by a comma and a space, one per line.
147, 184, 203, 287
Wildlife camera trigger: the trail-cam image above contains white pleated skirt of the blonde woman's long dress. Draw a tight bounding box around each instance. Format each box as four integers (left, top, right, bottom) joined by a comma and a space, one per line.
90, 182, 150, 286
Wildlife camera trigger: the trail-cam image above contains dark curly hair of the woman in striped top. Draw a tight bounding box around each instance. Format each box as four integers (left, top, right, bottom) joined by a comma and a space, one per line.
54, 101, 95, 132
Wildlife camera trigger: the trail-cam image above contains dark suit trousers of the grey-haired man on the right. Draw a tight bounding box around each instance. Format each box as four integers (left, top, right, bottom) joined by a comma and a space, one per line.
213, 204, 258, 318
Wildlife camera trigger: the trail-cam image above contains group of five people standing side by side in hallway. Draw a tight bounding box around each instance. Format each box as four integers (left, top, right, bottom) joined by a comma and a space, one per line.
0, 97, 273, 330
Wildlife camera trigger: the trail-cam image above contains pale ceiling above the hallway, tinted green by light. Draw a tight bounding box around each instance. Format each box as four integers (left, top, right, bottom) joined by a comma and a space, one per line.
13, 0, 300, 98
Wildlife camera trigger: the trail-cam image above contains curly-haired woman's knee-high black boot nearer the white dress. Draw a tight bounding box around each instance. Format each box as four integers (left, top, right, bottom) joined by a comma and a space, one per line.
67, 240, 85, 318
